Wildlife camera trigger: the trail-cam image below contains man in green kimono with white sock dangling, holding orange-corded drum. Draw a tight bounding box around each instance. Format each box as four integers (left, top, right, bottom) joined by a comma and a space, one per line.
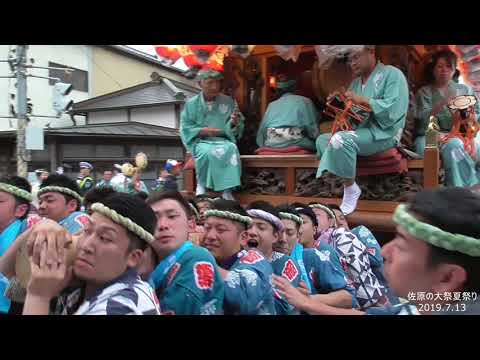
316, 45, 408, 215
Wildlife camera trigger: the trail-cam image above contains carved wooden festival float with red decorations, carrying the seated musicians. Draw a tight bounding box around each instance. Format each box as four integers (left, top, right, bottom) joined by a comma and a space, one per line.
155, 45, 480, 234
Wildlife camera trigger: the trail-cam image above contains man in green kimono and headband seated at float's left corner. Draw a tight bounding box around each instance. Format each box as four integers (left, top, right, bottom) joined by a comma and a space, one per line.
180, 70, 244, 200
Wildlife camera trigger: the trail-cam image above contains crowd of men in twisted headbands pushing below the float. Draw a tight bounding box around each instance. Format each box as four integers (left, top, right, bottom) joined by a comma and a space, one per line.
0, 170, 480, 315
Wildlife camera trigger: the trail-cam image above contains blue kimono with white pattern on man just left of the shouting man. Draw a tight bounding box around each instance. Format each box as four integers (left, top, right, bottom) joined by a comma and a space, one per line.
223, 250, 276, 315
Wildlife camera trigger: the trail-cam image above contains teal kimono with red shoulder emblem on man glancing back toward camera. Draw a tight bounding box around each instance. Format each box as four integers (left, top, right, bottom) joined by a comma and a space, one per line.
149, 242, 224, 315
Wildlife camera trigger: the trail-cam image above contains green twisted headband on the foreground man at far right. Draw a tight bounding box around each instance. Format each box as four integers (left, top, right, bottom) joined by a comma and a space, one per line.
393, 204, 480, 257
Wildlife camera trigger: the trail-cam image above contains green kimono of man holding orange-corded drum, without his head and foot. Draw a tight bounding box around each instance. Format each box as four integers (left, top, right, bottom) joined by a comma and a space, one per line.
316, 62, 409, 179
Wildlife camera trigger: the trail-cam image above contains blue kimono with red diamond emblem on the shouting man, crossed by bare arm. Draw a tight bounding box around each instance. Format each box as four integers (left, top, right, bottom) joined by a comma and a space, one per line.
270, 251, 302, 315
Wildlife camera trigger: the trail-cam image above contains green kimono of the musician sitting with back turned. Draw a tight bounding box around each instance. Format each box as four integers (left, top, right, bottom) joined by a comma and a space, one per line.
257, 93, 318, 150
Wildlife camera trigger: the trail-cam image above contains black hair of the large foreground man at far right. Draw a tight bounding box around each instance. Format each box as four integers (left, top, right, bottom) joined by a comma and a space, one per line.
409, 187, 480, 292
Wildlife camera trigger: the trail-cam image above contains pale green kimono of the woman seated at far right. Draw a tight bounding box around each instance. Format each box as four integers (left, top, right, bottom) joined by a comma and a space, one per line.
415, 81, 480, 187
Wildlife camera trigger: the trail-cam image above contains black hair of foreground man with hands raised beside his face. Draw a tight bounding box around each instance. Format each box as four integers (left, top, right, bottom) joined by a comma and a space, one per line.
99, 192, 157, 251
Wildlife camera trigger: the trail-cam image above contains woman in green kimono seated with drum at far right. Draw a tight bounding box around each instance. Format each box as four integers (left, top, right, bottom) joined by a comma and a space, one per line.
415, 50, 480, 187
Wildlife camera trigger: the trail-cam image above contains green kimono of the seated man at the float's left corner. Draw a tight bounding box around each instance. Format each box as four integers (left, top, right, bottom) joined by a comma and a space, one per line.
180, 93, 244, 191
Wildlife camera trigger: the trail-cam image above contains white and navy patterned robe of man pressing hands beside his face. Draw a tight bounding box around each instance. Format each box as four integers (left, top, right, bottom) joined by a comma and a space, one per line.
56, 269, 160, 315
